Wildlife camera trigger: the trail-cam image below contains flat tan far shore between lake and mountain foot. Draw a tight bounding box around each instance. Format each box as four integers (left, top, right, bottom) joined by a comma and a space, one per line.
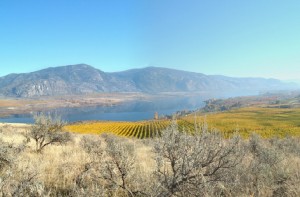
0, 92, 204, 118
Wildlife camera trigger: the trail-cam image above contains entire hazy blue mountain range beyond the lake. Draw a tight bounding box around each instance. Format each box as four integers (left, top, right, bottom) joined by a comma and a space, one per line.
0, 64, 296, 98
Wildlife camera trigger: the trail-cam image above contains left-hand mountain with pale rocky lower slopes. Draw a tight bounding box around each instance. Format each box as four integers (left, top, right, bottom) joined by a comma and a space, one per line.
0, 64, 136, 97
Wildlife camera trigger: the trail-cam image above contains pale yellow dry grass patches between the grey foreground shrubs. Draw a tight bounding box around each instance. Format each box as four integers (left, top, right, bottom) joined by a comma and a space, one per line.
0, 124, 155, 192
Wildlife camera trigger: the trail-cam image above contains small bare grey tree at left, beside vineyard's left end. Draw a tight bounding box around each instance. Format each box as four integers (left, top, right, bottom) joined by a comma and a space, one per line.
29, 114, 71, 152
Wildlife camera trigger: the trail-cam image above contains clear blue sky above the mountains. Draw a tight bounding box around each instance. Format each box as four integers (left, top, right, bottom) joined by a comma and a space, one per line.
0, 0, 300, 79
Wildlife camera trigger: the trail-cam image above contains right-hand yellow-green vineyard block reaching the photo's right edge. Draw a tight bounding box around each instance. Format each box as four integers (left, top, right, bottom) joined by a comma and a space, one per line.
183, 107, 300, 138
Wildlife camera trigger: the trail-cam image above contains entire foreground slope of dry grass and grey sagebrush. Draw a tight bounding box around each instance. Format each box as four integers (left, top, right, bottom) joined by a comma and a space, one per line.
0, 121, 300, 197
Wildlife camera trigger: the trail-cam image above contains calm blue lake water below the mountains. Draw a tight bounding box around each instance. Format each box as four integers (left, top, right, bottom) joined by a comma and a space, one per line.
0, 93, 258, 123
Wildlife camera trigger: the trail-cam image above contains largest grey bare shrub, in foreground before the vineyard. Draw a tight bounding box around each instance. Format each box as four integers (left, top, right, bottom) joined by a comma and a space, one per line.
154, 121, 243, 196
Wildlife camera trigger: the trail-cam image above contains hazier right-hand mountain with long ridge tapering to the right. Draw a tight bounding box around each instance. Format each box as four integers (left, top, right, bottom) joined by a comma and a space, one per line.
113, 67, 295, 92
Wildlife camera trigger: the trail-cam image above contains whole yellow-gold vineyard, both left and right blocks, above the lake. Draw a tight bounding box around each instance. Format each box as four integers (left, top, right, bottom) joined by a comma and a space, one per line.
66, 108, 300, 139
